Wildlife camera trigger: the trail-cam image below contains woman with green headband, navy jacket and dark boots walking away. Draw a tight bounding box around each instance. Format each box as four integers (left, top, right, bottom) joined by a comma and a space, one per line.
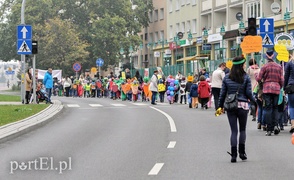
218, 57, 255, 163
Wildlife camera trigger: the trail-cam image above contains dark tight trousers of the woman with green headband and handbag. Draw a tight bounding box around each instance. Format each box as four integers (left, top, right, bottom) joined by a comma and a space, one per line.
227, 108, 249, 147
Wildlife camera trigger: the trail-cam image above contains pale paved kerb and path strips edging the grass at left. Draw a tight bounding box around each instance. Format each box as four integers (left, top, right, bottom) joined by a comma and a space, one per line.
0, 100, 63, 143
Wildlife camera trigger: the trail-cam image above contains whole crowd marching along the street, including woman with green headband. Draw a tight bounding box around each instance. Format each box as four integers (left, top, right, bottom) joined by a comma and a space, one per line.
26, 50, 294, 162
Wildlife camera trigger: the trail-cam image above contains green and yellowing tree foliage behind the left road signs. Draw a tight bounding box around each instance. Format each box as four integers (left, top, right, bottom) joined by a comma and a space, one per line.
0, 0, 153, 73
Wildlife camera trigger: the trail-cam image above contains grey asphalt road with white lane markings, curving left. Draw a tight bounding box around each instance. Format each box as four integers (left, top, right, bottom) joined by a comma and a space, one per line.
0, 97, 294, 180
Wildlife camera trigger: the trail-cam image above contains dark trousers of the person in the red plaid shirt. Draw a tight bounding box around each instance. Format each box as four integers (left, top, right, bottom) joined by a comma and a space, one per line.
262, 93, 279, 131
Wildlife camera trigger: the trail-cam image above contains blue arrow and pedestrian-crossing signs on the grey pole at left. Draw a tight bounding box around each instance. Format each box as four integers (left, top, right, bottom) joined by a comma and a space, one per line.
16, 25, 32, 54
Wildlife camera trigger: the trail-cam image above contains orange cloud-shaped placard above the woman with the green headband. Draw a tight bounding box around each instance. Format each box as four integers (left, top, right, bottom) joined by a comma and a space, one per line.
241, 36, 262, 53
